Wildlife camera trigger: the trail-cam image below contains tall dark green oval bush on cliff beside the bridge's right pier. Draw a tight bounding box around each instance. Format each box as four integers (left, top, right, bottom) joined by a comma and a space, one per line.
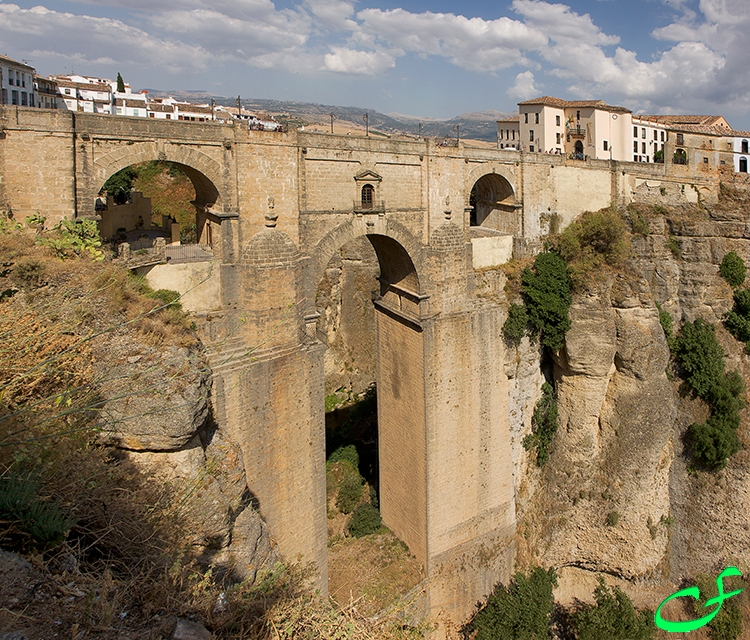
521, 252, 572, 351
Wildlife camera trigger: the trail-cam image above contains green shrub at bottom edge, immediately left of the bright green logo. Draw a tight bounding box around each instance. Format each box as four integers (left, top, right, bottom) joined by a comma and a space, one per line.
571, 578, 656, 640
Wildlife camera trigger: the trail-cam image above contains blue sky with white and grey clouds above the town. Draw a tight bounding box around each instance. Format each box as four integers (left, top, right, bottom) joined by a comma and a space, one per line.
0, 0, 750, 129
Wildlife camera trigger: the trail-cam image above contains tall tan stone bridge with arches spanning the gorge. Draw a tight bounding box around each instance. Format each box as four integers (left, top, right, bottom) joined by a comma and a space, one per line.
0, 107, 715, 632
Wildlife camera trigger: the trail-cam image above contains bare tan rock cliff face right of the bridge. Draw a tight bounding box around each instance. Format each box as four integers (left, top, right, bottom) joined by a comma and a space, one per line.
519, 205, 750, 592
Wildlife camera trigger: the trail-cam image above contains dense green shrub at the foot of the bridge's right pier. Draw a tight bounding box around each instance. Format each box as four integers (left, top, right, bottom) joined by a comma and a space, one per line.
466, 567, 557, 640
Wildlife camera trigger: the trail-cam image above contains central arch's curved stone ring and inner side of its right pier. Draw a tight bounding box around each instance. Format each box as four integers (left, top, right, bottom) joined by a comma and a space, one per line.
312, 219, 427, 566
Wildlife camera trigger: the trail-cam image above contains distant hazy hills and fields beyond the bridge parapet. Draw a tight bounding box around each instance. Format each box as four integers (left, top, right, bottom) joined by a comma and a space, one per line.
148, 89, 513, 142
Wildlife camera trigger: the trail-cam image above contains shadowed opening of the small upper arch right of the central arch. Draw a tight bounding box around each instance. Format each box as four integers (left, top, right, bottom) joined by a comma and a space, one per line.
469, 173, 520, 235
